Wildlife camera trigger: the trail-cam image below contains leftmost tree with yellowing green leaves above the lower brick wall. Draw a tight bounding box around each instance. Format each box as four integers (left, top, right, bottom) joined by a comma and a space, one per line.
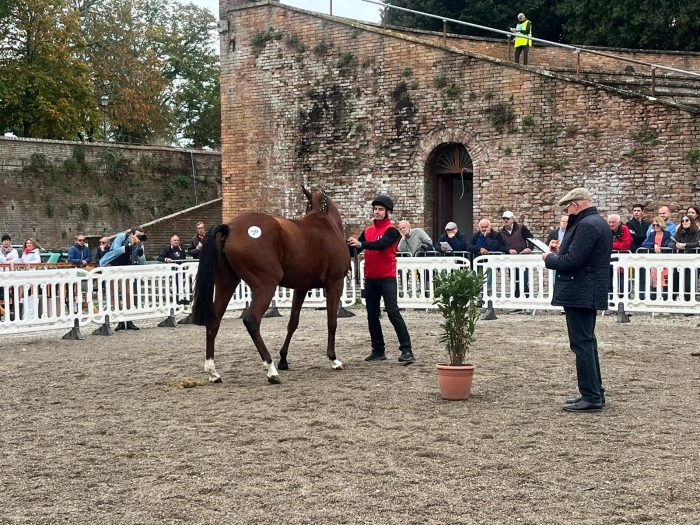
0, 0, 95, 139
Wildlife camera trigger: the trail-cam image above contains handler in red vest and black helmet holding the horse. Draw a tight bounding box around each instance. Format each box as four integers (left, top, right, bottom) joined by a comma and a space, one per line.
347, 195, 416, 365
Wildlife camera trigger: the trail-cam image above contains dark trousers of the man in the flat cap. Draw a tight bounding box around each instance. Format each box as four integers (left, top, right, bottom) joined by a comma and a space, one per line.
564, 306, 605, 403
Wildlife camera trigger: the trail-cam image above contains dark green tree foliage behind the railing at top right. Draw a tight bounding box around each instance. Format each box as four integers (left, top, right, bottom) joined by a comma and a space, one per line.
383, 0, 700, 51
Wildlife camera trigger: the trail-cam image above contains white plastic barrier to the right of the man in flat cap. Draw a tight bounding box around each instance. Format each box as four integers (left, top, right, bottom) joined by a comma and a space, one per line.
610, 253, 700, 314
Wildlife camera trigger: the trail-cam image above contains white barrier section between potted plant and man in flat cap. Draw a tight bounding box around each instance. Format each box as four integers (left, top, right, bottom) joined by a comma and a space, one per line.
473, 253, 560, 310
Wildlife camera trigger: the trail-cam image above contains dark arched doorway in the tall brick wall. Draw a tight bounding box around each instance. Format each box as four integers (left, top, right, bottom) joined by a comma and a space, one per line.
429, 143, 474, 239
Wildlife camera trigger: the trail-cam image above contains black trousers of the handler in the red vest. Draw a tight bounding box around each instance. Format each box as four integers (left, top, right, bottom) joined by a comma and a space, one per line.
365, 277, 411, 354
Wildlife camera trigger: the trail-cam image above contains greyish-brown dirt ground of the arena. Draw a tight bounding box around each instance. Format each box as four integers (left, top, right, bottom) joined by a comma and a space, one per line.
0, 309, 700, 525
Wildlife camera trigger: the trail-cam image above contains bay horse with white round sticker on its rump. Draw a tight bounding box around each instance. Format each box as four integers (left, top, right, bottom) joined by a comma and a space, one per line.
192, 186, 350, 383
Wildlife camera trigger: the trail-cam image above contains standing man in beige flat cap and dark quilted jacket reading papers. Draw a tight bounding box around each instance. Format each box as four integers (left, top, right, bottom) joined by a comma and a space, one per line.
542, 188, 612, 412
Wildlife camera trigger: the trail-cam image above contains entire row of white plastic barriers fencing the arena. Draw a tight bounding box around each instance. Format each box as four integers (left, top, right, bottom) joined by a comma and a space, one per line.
0, 254, 700, 334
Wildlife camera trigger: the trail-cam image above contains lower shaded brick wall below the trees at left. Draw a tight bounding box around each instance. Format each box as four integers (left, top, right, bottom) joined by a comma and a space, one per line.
0, 138, 221, 248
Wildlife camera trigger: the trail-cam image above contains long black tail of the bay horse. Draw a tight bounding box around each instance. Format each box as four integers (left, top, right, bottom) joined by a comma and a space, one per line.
192, 224, 229, 326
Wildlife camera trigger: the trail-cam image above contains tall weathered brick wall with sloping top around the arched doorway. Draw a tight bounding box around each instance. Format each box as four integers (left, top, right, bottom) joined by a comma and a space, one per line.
221, 2, 700, 239
